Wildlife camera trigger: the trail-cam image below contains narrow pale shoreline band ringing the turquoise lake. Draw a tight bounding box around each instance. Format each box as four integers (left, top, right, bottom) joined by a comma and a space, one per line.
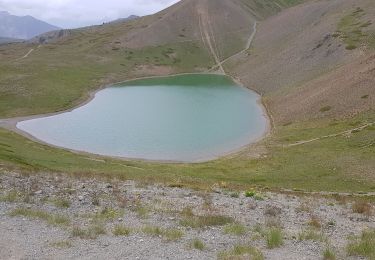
0, 73, 273, 164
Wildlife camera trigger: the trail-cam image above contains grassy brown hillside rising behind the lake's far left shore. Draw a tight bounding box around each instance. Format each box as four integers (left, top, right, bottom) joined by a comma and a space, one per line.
0, 0, 302, 117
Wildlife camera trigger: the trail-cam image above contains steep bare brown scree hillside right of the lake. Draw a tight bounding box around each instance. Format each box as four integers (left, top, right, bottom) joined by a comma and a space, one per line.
225, 0, 375, 124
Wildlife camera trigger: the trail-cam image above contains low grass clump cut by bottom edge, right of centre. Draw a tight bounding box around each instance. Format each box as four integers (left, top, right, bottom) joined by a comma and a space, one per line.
218, 245, 264, 260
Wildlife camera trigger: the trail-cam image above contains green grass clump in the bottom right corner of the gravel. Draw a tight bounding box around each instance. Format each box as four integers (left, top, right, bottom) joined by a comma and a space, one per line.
347, 230, 375, 260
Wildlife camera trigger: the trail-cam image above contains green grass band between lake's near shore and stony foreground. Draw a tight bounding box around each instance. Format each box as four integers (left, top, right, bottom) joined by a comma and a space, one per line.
0, 112, 375, 192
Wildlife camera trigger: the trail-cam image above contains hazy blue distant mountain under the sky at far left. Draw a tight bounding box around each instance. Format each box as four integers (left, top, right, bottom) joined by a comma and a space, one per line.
0, 11, 60, 39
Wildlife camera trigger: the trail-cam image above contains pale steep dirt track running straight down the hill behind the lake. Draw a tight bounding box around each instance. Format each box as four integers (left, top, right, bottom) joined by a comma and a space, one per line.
197, 1, 225, 74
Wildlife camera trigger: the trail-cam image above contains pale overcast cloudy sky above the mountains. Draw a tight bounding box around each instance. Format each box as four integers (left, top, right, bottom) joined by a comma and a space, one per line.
0, 0, 179, 28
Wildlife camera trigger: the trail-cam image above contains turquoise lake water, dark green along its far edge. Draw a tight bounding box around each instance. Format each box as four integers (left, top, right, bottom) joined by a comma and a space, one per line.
17, 74, 267, 162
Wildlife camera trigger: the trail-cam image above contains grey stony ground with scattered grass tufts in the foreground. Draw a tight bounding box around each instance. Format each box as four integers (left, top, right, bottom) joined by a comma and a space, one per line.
0, 170, 375, 260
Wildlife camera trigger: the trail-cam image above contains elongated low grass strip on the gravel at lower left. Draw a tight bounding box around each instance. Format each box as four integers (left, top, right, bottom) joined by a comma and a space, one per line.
9, 207, 70, 226
